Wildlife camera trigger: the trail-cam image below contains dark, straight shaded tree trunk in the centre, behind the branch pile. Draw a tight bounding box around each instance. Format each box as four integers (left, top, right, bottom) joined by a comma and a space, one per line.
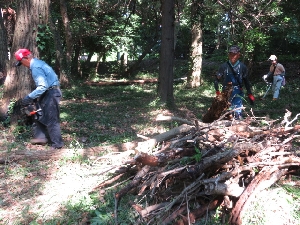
158, 0, 175, 106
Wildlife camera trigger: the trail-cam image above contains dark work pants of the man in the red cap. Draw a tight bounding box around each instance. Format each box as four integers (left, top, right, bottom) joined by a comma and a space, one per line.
33, 89, 64, 148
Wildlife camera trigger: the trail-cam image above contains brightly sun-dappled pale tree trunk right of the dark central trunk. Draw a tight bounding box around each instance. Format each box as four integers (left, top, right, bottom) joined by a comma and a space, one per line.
187, 0, 203, 88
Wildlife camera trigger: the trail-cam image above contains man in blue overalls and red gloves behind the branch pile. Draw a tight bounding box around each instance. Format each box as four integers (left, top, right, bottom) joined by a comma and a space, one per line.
214, 45, 255, 119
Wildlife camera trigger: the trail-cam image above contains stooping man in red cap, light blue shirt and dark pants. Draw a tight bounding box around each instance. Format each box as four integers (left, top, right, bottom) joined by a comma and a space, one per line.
15, 49, 63, 149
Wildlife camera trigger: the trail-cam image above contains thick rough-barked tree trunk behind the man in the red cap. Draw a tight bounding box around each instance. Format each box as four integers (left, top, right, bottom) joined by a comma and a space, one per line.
1, 0, 49, 124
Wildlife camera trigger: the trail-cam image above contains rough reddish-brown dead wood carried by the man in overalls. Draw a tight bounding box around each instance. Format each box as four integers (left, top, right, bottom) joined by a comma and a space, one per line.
202, 85, 232, 123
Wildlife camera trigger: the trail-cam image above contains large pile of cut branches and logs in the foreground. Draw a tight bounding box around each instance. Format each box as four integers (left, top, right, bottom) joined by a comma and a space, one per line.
99, 111, 300, 225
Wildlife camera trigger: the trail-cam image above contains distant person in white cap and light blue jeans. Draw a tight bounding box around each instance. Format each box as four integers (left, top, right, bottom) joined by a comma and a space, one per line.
264, 55, 285, 100
